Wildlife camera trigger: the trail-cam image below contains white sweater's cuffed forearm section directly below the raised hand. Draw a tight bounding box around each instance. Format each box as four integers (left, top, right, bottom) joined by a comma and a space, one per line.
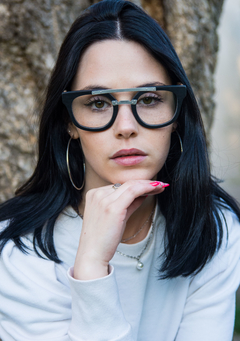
68, 267, 133, 341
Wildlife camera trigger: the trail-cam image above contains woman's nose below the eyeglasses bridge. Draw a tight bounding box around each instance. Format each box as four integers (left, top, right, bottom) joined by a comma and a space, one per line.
113, 104, 139, 139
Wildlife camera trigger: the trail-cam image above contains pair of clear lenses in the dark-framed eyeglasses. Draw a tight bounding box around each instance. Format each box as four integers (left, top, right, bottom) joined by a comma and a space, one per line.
72, 90, 177, 128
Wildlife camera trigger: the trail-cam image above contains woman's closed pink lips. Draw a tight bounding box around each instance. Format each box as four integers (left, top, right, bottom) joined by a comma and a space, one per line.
111, 148, 147, 166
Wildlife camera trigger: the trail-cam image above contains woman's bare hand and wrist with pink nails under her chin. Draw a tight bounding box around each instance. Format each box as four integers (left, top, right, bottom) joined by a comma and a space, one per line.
74, 180, 166, 280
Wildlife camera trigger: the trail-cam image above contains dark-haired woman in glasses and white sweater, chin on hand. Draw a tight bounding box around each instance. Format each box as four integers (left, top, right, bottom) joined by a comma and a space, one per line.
0, 0, 240, 341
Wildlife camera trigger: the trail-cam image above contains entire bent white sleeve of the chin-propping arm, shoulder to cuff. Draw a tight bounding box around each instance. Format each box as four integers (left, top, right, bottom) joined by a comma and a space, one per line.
0, 236, 132, 341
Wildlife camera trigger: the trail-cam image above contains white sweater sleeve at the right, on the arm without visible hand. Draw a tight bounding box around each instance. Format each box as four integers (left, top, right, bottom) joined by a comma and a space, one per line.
175, 211, 240, 341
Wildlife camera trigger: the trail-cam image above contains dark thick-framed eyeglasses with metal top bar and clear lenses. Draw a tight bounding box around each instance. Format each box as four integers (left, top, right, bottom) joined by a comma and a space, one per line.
62, 85, 187, 131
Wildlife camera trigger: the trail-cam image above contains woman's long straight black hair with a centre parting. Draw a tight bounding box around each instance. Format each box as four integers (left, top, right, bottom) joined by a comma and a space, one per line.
0, 0, 240, 278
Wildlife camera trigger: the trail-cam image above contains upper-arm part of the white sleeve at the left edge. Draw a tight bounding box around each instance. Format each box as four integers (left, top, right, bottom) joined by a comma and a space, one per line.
0, 236, 71, 341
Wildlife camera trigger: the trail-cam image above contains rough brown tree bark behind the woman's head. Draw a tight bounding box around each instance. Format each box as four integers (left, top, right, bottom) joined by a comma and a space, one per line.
0, 0, 223, 201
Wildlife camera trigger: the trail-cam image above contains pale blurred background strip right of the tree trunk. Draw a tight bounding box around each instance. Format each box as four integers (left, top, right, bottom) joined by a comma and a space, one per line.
210, 0, 240, 202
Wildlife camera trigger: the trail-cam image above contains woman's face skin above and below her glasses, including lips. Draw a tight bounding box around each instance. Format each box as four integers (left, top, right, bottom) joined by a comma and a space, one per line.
69, 40, 175, 190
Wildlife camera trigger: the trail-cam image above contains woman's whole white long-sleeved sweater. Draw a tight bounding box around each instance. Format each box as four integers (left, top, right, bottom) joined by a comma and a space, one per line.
0, 208, 240, 341
